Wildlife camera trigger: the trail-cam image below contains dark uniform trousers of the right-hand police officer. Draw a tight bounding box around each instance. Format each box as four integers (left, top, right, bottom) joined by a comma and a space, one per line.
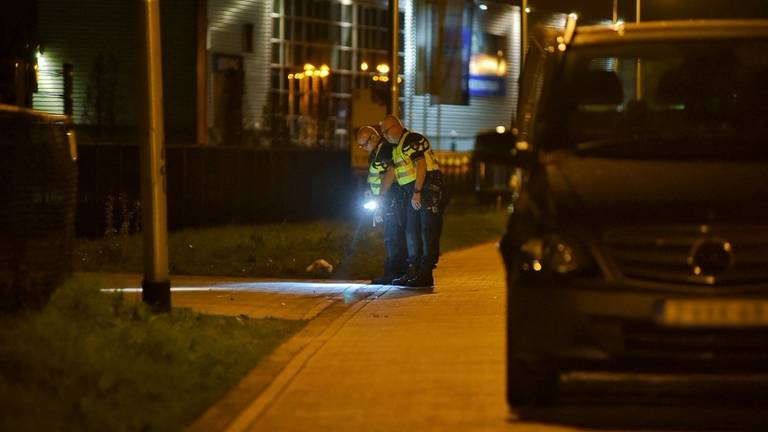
403, 170, 447, 272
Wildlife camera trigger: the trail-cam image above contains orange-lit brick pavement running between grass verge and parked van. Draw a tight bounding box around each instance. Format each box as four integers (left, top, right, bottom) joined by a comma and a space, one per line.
198, 244, 562, 431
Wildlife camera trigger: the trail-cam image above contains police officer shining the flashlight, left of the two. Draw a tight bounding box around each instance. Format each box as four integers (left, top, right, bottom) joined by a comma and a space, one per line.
355, 126, 407, 285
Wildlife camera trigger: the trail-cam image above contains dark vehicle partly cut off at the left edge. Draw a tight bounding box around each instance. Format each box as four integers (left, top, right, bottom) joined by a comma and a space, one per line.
0, 103, 78, 314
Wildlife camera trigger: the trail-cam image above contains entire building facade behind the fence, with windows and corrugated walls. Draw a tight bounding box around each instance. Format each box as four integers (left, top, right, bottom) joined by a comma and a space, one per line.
33, 0, 520, 150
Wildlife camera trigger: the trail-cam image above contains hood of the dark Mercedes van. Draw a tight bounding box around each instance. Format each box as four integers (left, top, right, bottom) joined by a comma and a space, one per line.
545, 153, 768, 227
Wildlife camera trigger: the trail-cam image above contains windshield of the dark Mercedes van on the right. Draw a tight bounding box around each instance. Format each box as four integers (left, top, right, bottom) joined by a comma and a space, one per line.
541, 39, 768, 159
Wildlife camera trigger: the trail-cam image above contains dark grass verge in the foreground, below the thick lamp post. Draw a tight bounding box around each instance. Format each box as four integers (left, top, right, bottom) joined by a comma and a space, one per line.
0, 280, 305, 431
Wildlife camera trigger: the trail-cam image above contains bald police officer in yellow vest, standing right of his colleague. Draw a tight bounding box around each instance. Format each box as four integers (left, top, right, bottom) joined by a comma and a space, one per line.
380, 115, 446, 287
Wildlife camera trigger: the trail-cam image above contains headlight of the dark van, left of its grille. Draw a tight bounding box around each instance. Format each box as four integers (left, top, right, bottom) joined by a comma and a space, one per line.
520, 235, 597, 275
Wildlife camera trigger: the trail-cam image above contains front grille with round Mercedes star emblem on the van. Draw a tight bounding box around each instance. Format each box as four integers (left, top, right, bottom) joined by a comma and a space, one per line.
603, 226, 768, 286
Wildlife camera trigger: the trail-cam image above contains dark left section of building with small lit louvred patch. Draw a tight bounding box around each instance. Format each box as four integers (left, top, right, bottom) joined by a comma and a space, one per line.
33, 0, 196, 144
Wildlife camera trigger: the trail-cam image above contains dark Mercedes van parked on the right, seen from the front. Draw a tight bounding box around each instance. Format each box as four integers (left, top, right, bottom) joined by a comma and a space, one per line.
500, 20, 768, 406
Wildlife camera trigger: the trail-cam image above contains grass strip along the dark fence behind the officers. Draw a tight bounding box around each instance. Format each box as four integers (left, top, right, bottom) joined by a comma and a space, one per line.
75, 208, 507, 279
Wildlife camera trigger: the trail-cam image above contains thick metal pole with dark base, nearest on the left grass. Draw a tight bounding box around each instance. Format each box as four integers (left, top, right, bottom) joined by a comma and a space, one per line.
139, 0, 171, 312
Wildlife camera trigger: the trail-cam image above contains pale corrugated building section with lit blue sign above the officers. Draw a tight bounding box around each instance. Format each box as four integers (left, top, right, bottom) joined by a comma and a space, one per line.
401, 0, 521, 151
